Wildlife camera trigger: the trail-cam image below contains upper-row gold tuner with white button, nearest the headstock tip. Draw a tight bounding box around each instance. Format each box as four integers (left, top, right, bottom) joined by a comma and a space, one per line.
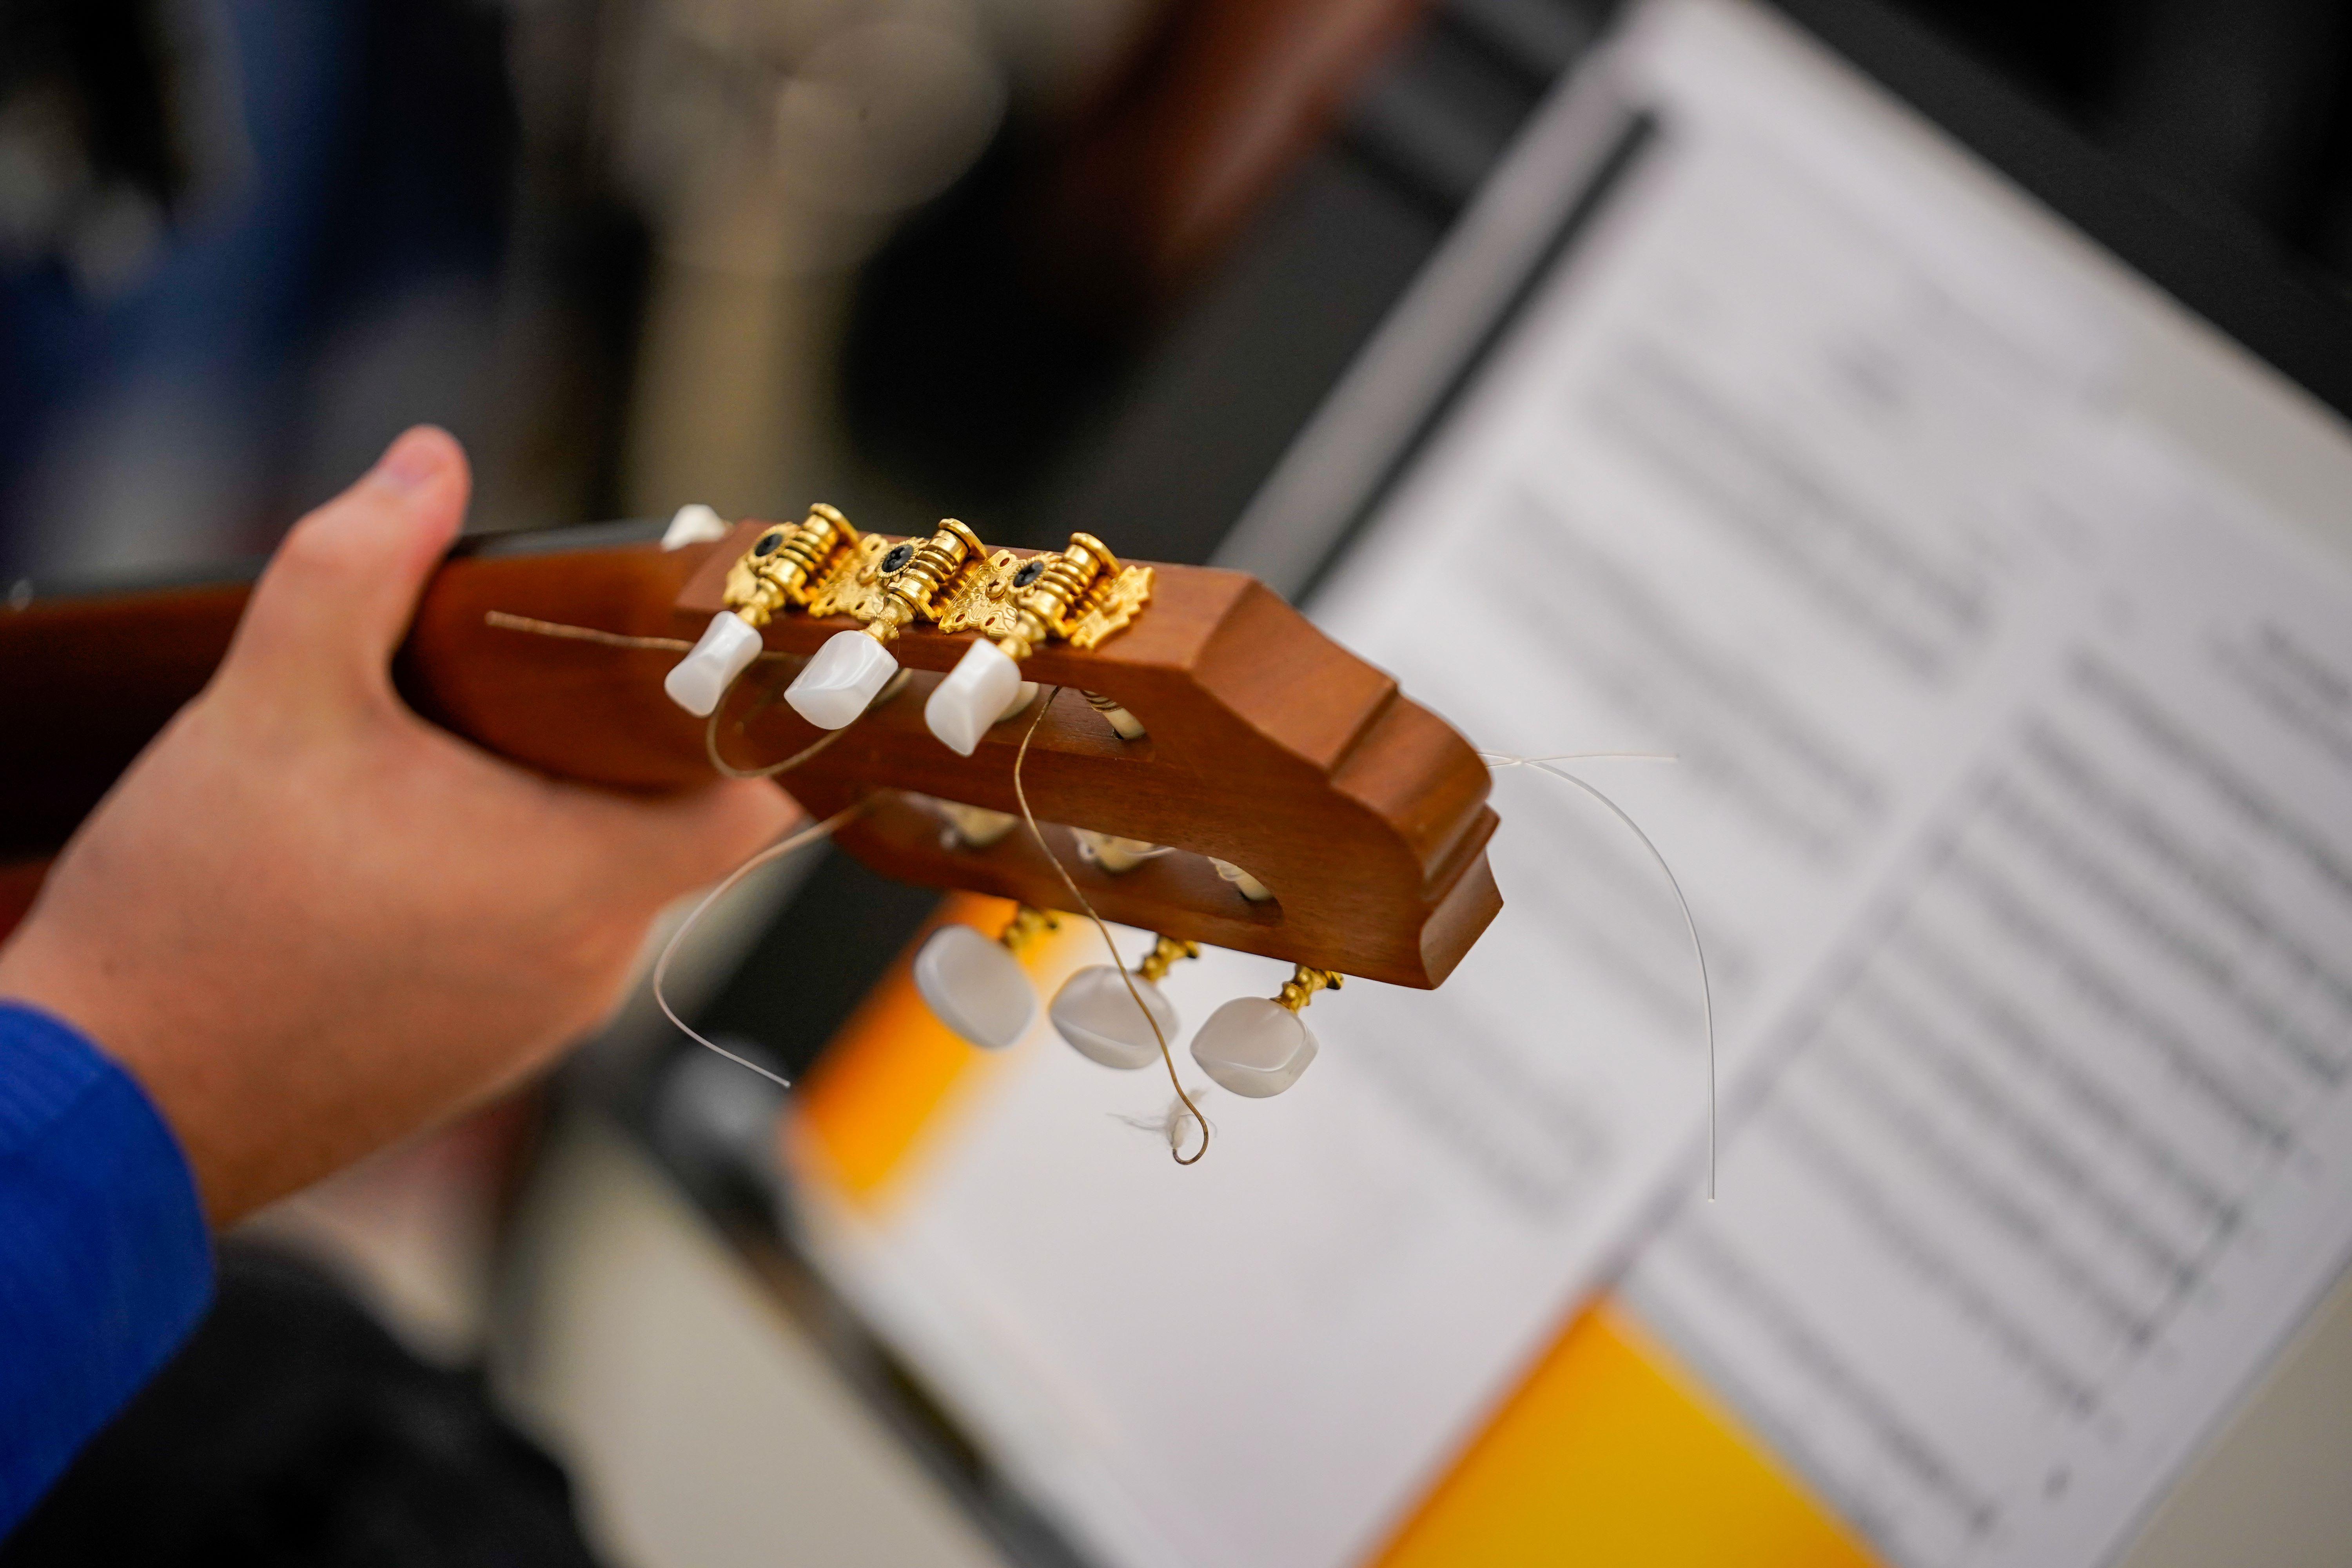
922, 534, 1152, 757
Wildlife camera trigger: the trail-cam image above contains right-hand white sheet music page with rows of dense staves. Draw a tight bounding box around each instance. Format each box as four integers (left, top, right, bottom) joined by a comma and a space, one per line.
1630, 451, 2352, 1566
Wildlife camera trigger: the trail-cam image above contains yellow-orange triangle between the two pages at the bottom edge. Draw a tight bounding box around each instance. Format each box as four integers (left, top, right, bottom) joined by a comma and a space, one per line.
1374, 1298, 1877, 1568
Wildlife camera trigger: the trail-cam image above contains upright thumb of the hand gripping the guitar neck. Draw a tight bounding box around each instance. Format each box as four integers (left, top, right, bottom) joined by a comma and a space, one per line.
228, 425, 473, 701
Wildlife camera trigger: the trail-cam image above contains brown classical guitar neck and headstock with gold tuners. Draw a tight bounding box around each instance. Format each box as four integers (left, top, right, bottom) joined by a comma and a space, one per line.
0, 505, 1501, 1093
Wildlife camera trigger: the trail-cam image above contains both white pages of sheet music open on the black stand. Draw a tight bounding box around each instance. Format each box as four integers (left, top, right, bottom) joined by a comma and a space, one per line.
790, 2, 2352, 1568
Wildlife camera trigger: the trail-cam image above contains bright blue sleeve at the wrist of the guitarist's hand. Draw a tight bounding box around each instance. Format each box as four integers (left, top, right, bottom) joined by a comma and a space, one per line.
0, 1002, 212, 1533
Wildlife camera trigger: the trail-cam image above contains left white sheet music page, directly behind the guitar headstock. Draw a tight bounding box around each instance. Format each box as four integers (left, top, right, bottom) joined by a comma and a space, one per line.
795, 7, 2296, 1568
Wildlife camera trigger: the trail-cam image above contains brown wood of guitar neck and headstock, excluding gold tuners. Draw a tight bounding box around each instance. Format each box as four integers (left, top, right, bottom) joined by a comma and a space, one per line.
0, 522, 1501, 987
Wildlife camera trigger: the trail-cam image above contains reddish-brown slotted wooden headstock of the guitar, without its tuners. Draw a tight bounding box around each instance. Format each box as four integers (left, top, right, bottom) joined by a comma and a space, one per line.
675, 522, 1501, 987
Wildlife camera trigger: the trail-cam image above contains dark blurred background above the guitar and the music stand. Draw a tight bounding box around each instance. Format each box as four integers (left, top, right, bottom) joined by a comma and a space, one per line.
14, 0, 2352, 588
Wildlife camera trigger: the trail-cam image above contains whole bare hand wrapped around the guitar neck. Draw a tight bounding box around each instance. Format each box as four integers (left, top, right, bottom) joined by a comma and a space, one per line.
0, 428, 793, 1225
